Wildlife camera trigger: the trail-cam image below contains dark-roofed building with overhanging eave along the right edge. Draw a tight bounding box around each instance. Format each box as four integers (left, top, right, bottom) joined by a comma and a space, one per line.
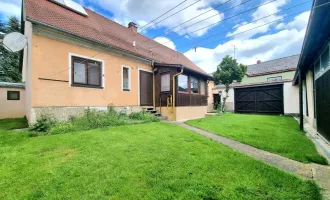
293, 0, 330, 141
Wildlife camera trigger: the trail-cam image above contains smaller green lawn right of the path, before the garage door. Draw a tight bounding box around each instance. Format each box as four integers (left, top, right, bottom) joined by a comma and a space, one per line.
186, 114, 327, 164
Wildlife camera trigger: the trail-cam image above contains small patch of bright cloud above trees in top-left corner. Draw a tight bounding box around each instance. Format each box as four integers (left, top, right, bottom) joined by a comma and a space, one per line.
0, 0, 21, 19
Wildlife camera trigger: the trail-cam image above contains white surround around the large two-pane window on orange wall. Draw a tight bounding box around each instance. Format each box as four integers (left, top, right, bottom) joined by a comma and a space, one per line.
68, 52, 105, 90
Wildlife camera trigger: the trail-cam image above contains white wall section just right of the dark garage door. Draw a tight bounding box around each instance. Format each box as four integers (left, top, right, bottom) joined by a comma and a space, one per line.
283, 82, 299, 114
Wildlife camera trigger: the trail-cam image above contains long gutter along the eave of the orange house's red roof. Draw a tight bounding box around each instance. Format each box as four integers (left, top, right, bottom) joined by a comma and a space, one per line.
26, 17, 155, 62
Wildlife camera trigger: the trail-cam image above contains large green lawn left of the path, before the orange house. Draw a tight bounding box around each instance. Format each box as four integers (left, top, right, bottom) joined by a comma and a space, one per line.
0, 120, 321, 199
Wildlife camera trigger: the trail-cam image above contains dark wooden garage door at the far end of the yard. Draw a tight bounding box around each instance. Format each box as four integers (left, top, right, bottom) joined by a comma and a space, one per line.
235, 85, 284, 114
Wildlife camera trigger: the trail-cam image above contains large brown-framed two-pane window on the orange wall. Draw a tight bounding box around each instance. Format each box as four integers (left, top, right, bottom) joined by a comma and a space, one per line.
71, 57, 102, 88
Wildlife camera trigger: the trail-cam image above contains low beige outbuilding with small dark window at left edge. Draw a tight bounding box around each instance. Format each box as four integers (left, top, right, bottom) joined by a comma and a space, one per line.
0, 82, 25, 119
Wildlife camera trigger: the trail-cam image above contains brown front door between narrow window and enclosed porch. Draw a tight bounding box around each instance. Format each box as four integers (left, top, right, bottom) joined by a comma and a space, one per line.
139, 70, 154, 106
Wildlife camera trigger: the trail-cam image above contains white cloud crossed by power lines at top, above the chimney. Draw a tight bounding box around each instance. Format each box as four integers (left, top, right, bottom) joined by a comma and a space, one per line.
84, 0, 228, 36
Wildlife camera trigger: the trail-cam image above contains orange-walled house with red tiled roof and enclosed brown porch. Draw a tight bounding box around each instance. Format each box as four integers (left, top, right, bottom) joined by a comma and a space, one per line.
14, 0, 212, 123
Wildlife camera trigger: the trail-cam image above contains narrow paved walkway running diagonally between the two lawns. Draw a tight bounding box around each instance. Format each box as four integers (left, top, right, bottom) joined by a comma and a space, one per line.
172, 122, 330, 200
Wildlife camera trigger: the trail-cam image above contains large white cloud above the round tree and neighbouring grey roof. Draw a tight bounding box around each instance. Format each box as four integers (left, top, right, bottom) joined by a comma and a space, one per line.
185, 10, 309, 73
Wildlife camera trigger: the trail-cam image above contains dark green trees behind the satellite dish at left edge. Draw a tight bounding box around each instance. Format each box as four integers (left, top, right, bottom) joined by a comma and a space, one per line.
0, 16, 22, 82
